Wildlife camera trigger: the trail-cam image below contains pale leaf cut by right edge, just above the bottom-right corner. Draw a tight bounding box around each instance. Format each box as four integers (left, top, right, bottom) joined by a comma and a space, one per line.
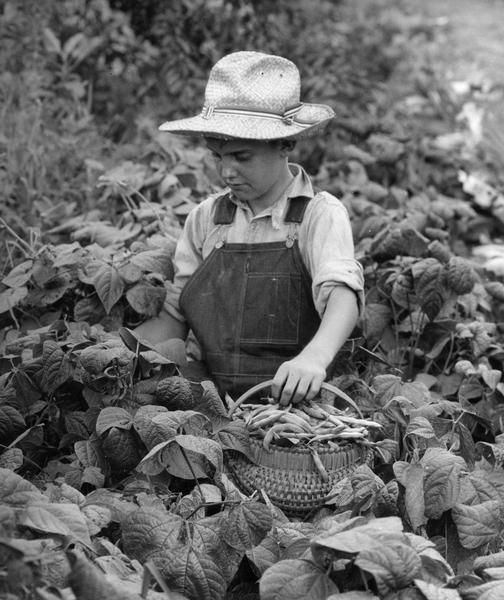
452, 500, 501, 549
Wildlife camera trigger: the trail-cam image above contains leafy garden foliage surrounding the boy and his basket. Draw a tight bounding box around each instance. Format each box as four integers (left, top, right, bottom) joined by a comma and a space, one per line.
0, 0, 504, 600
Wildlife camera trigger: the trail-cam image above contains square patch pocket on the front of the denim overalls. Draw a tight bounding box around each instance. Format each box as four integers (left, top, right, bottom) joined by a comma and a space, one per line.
240, 273, 302, 345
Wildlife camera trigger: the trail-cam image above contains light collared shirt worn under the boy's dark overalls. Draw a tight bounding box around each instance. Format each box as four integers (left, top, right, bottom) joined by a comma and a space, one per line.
164, 164, 364, 321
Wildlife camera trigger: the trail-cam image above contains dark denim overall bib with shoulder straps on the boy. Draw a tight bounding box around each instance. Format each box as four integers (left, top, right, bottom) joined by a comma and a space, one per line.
180, 195, 320, 399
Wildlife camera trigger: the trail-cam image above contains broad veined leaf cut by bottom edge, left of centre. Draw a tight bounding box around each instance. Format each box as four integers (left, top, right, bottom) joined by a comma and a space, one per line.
154, 545, 227, 600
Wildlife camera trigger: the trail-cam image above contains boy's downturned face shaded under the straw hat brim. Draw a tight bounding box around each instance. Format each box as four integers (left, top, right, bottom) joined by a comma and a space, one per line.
206, 138, 288, 204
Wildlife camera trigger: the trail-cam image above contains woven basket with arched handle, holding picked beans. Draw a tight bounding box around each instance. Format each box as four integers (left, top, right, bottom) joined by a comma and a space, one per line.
226, 381, 373, 518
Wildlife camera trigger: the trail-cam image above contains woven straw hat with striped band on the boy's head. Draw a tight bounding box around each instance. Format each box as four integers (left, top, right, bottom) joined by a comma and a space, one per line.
159, 52, 334, 140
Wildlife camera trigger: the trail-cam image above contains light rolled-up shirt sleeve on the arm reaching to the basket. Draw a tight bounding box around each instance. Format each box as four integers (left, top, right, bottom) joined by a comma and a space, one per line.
299, 192, 364, 315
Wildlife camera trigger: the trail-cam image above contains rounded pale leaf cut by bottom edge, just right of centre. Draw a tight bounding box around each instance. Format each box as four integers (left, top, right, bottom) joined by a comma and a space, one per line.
259, 559, 338, 600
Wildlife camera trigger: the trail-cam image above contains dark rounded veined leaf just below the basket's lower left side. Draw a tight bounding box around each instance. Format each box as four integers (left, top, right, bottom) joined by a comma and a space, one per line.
220, 500, 273, 552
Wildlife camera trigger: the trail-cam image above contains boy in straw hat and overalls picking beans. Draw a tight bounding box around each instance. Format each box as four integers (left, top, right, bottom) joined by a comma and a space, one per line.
136, 52, 364, 404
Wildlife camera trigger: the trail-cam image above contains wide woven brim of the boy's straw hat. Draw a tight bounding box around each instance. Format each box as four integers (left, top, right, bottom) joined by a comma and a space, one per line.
159, 104, 334, 141
